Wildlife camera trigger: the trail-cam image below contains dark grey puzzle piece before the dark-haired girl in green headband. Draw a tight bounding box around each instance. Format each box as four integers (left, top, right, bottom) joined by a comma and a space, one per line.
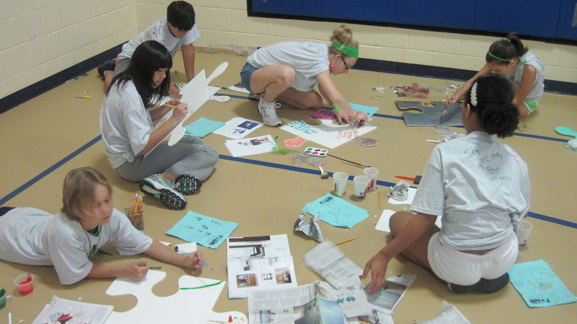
395, 101, 463, 126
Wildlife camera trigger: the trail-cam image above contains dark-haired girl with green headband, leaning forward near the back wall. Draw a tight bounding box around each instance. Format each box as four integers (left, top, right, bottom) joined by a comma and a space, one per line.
447, 33, 544, 118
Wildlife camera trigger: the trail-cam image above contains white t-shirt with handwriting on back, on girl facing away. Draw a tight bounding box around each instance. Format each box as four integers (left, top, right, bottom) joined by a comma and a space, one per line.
411, 132, 531, 251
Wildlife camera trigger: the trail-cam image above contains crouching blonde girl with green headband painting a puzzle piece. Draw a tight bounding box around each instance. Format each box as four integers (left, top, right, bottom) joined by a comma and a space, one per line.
240, 26, 368, 126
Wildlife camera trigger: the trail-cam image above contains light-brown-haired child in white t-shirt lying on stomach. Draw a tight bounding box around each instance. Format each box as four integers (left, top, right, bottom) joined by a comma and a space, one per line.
0, 168, 203, 285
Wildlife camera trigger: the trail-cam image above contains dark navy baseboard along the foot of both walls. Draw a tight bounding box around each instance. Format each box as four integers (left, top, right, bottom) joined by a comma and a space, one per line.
0, 44, 577, 114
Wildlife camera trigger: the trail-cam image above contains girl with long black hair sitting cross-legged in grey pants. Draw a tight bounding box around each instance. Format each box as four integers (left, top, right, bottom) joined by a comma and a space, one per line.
100, 41, 218, 209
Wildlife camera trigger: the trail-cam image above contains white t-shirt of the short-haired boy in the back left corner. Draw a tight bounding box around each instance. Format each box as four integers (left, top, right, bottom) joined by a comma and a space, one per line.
118, 16, 200, 59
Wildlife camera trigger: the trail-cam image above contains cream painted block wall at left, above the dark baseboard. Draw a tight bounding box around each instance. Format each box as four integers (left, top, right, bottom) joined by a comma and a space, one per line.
0, 0, 136, 98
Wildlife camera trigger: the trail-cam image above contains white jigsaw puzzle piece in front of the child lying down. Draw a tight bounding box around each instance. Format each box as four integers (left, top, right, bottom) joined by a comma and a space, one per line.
106, 270, 226, 324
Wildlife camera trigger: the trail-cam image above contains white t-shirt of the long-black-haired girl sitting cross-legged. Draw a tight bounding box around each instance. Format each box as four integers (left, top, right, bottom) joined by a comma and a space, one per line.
100, 80, 154, 169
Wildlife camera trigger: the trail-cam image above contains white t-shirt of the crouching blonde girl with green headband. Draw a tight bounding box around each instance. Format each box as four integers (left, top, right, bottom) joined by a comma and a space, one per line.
246, 41, 330, 92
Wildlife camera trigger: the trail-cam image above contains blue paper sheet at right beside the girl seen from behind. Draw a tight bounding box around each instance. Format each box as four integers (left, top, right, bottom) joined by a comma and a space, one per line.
509, 259, 577, 307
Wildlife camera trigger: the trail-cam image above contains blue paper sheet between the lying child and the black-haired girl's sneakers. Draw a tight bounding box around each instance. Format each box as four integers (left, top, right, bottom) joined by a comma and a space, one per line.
166, 210, 238, 249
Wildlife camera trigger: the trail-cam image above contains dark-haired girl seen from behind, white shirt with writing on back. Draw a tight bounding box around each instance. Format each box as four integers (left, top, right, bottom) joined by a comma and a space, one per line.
363, 75, 531, 294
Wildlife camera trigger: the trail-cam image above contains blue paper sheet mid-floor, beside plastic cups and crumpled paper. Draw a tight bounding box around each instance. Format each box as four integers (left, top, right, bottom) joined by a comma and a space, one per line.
303, 193, 369, 228
